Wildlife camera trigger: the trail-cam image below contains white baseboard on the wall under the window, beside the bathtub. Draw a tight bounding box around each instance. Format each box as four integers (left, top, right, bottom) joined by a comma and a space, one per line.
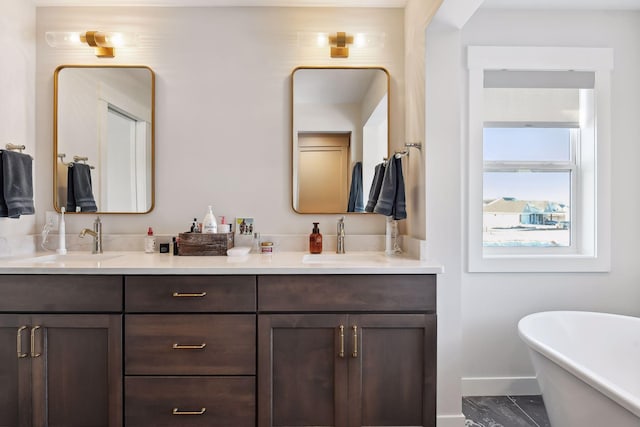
462, 377, 540, 396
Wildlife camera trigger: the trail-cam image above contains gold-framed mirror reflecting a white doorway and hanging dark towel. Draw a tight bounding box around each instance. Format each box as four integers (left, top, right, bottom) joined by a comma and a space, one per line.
53, 65, 155, 213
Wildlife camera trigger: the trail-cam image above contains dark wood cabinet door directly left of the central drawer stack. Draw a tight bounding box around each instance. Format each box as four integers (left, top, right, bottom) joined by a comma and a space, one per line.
31, 315, 122, 427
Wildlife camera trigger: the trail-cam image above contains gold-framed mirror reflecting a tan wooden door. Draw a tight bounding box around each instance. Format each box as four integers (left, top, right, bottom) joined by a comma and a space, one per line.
292, 67, 389, 213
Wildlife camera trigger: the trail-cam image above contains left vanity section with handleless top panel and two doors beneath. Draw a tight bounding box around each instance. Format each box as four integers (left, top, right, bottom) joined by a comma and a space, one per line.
0, 275, 122, 427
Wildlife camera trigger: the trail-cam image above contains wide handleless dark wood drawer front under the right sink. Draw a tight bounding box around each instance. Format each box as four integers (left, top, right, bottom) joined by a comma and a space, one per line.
258, 274, 436, 312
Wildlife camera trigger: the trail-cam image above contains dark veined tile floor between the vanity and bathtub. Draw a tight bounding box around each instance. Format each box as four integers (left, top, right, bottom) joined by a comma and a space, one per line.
462, 396, 551, 427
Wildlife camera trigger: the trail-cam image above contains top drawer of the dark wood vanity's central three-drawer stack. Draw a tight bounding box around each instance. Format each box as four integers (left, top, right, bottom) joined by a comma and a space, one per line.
125, 275, 256, 313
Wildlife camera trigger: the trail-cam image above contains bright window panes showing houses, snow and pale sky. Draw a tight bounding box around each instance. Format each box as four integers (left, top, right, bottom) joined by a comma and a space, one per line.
483, 125, 579, 247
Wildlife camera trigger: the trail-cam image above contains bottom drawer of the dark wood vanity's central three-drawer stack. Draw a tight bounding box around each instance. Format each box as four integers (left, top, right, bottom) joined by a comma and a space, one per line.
125, 377, 256, 427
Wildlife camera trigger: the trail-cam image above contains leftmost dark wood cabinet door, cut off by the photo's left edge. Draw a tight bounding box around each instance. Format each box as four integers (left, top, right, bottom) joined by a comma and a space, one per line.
0, 314, 31, 427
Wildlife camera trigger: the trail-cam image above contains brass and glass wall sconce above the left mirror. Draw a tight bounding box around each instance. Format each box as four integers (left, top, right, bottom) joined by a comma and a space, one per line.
45, 31, 137, 58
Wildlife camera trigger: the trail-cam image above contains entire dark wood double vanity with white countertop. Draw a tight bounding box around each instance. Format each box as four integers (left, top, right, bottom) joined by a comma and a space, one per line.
0, 253, 442, 427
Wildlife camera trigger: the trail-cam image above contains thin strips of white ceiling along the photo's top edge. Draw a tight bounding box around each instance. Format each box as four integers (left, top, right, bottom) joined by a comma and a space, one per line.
33, 0, 640, 10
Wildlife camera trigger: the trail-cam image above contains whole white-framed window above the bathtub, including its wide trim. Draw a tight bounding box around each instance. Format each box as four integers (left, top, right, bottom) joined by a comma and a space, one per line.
468, 47, 613, 271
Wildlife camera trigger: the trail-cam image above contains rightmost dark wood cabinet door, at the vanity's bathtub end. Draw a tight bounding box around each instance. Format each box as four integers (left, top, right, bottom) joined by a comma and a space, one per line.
348, 314, 436, 427
